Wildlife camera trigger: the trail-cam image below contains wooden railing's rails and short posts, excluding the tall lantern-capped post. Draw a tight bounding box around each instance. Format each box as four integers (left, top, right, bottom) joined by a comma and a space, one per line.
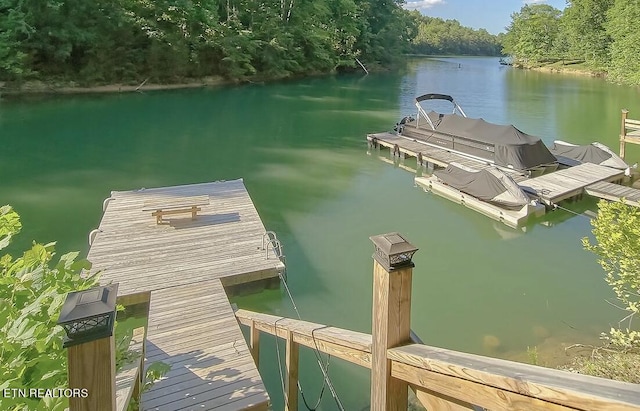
236, 310, 640, 411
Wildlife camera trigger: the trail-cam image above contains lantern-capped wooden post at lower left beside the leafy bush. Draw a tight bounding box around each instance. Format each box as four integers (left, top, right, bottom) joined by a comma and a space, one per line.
58, 284, 118, 411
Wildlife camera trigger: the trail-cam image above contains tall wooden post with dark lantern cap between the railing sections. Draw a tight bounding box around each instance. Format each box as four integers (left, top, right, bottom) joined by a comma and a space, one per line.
371, 233, 417, 411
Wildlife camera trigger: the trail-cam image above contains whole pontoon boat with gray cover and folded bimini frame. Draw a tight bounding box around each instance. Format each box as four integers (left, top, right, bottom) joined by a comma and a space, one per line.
396, 94, 558, 174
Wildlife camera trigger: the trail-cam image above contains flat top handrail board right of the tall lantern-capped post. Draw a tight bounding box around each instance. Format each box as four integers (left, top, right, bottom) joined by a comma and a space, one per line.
387, 344, 640, 411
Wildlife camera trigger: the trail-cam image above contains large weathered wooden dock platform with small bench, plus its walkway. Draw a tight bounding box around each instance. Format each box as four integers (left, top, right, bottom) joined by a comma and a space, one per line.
88, 180, 284, 411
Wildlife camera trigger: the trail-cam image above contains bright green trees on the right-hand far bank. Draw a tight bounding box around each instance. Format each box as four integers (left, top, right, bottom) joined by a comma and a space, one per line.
503, 0, 640, 85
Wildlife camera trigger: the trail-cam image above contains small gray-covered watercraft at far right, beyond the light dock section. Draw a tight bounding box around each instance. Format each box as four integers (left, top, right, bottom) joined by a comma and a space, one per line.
550, 140, 631, 175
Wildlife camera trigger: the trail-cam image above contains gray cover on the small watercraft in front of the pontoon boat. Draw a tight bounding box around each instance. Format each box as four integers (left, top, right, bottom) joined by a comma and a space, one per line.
433, 163, 530, 208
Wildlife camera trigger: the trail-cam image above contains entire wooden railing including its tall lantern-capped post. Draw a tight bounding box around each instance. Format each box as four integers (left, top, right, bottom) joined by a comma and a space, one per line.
236, 233, 640, 411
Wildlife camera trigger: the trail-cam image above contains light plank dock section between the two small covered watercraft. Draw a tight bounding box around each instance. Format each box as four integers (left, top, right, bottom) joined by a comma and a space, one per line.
518, 163, 624, 205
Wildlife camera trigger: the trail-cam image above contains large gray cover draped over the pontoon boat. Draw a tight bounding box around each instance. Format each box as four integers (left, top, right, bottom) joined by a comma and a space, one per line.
420, 111, 557, 170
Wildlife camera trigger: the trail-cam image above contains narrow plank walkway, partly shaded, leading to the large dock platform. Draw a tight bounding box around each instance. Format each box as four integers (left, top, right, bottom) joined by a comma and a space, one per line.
142, 279, 269, 411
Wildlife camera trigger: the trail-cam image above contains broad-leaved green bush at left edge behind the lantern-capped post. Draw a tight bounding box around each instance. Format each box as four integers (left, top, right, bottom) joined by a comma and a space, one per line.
0, 206, 97, 410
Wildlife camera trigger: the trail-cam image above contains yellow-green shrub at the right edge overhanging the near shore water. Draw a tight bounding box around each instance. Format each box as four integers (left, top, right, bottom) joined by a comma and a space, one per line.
582, 200, 640, 350
